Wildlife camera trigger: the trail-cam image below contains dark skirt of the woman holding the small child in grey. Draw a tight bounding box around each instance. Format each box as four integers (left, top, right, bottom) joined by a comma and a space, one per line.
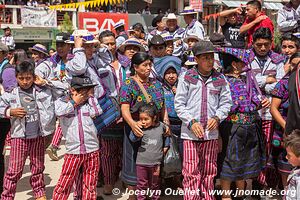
121, 124, 140, 186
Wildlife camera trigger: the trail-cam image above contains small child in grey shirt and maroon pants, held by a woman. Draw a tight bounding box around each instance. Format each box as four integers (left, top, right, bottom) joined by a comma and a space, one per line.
129, 104, 167, 200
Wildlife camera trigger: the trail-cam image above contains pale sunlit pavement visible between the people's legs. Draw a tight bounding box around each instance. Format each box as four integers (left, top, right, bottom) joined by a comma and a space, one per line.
5, 141, 182, 200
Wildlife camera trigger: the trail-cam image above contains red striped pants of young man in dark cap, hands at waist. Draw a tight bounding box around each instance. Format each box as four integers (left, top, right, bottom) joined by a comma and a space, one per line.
182, 140, 218, 200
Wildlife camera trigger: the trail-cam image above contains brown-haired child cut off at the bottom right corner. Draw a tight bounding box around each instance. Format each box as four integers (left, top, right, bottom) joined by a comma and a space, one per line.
284, 129, 300, 200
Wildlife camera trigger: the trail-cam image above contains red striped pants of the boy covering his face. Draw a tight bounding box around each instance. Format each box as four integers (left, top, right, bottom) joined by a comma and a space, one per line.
53, 151, 100, 200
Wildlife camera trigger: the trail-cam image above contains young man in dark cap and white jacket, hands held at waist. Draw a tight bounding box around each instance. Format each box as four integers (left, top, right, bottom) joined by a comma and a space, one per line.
174, 41, 232, 200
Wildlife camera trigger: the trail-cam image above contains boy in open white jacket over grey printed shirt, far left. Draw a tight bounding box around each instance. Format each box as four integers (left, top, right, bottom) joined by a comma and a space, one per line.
0, 61, 55, 200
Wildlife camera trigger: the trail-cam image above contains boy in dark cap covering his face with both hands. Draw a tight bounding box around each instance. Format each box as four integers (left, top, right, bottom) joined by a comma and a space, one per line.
53, 75, 102, 200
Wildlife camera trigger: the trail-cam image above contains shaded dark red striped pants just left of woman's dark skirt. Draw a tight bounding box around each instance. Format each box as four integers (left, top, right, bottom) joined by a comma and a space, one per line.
100, 138, 123, 185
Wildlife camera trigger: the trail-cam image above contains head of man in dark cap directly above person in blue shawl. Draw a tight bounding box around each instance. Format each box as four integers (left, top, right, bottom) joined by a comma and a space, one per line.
149, 35, 166, 58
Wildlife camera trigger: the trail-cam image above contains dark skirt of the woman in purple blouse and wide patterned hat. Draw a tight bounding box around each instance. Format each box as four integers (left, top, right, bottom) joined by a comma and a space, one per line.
220, 122, 266, 181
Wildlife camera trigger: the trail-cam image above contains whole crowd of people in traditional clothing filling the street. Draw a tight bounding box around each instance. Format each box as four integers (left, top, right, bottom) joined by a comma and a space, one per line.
0, 0, 300, 200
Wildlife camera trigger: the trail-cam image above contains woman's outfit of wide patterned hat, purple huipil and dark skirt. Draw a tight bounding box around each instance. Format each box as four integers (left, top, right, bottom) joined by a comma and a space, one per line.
217, 48, 266, 181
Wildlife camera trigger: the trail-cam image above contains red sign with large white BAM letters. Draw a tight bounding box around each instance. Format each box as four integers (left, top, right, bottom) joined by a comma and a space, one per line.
78, 12, 128, 33
